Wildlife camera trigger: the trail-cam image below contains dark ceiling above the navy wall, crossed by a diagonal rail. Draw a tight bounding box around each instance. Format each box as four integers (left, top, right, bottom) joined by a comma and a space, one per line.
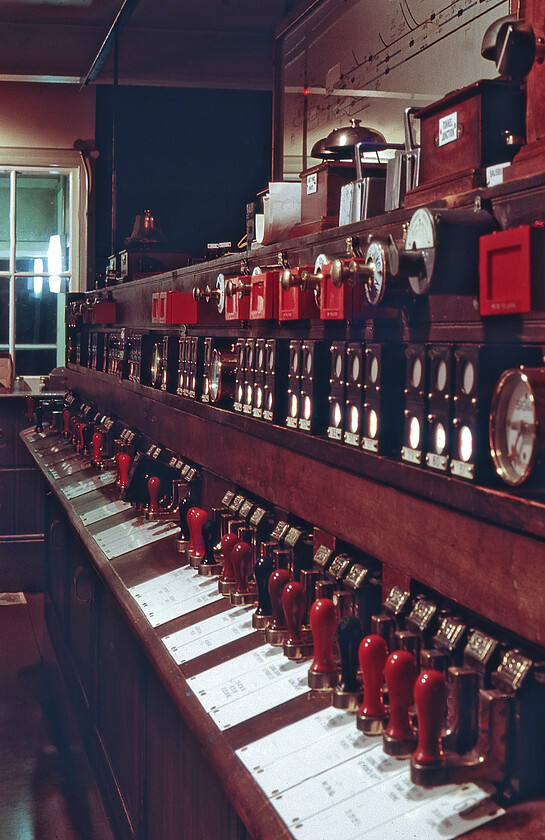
0, 0, 293, 88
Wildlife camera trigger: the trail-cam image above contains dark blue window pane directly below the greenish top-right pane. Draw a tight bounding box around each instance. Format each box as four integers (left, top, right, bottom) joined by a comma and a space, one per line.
15, 277, 57, 342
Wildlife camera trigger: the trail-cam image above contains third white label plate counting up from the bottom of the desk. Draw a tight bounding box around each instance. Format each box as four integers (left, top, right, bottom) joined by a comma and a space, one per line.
163, 607, 254, 665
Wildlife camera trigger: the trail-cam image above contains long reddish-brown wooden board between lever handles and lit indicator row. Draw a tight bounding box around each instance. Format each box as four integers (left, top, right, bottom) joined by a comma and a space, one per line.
66, 364, 545, 644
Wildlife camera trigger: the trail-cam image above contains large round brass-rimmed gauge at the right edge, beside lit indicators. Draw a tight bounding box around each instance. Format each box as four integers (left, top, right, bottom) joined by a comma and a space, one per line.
489, 370, 537, 486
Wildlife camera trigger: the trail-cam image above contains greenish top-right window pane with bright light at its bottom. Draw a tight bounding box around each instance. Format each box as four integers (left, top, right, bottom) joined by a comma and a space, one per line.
15, 174, 69, 274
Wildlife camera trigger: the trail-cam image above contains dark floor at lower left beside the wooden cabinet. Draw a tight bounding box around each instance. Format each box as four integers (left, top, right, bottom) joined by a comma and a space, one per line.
0, 594, 115, 840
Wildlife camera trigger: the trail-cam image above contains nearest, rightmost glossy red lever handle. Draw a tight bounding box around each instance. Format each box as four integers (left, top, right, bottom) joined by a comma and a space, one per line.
413, 671, 447, 764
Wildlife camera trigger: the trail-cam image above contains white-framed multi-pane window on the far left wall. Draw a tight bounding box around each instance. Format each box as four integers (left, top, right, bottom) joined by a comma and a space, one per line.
0, 150, 86, 376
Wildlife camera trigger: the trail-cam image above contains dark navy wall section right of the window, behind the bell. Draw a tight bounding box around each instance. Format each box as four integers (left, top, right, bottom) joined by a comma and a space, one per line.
96, 86, 272, 282
